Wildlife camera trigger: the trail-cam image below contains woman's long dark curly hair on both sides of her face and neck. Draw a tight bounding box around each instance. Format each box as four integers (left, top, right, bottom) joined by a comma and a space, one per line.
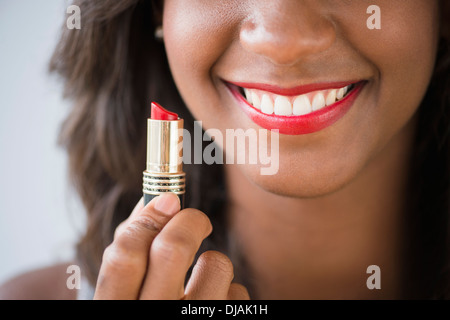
50, 0, 450, 298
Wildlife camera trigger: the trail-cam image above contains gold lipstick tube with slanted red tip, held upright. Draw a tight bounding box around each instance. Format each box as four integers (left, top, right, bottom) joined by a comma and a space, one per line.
142, 102, 186, 208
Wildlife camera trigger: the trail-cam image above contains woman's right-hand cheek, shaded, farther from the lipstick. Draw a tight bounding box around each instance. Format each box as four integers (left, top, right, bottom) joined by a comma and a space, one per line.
326, 0, 439, 172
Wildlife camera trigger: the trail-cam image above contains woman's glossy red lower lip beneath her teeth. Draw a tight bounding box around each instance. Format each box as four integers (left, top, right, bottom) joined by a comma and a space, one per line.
227, 82, 366, 135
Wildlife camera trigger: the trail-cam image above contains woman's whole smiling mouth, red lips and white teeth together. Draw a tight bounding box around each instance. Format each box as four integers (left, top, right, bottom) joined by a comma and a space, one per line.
225, 80, 367, 135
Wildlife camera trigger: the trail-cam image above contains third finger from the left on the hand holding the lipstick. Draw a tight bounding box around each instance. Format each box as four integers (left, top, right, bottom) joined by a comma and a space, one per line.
186, 251, 234, 300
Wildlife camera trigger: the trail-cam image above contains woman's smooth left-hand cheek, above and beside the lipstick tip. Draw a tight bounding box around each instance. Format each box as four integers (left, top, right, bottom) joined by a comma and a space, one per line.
163, 0, 236, 128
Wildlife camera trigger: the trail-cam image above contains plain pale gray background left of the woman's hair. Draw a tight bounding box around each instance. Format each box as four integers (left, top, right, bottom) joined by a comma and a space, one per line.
0, 0, 85, 283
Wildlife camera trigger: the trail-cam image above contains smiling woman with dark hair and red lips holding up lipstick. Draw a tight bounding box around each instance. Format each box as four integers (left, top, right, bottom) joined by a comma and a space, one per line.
3, 0, 450, 299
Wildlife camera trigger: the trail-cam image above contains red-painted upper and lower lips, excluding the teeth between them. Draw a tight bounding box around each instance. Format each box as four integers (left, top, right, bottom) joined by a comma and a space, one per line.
227, 82, 365, 135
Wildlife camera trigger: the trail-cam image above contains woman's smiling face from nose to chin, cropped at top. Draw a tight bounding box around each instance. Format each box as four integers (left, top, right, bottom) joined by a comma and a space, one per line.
163, 0, 439, 197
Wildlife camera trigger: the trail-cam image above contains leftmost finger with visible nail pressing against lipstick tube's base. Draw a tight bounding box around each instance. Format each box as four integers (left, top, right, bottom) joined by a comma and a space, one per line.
94, 194, 180, 299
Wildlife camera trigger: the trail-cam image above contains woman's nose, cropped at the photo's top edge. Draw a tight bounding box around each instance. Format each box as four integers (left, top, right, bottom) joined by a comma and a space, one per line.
239, 0, 336, 65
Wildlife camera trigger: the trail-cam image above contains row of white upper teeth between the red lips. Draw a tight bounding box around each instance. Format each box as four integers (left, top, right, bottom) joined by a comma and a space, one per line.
243, 86, 350, 116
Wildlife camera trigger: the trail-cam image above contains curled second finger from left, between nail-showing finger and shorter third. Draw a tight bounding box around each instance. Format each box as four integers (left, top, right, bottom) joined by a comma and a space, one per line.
141, 209, 212, 300
